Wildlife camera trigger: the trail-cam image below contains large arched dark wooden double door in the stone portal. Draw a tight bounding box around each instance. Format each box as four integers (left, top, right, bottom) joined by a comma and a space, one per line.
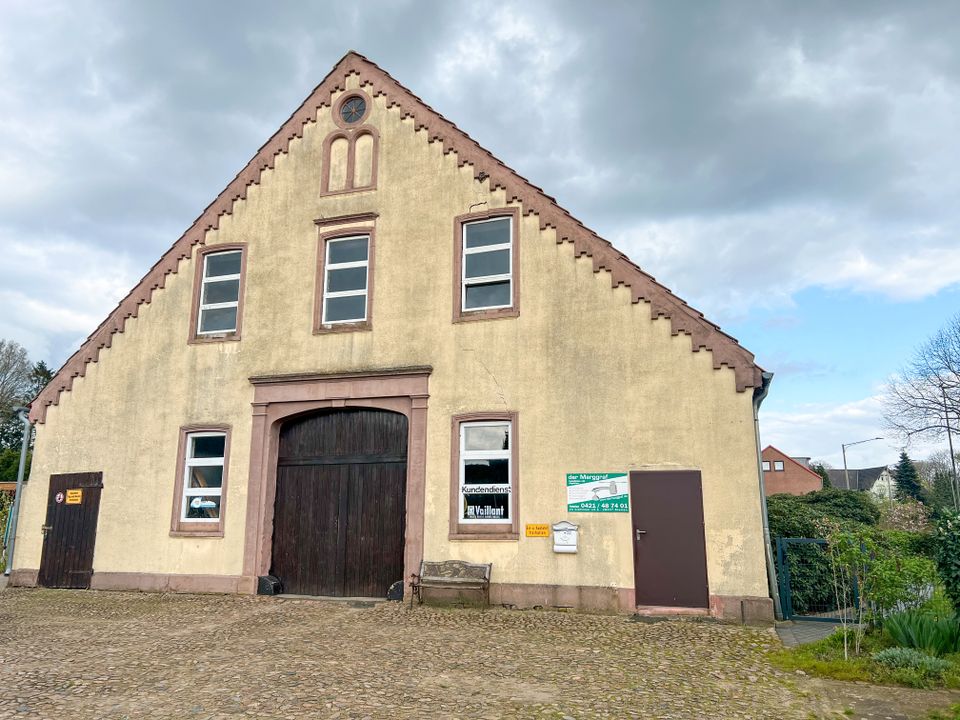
271, 409, 407, 597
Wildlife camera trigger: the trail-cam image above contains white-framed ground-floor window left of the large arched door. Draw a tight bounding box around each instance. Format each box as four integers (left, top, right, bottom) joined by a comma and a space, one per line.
180, 432, 227, 523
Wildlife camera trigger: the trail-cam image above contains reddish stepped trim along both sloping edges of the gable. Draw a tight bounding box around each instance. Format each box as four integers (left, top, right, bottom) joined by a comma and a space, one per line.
30, 51, 762, 422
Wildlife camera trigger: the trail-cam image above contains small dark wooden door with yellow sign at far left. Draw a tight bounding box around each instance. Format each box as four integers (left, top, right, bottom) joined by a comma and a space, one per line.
37, 472, 103, 588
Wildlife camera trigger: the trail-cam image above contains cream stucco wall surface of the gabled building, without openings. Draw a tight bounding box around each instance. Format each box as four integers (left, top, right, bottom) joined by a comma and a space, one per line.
15, 59, 768, 620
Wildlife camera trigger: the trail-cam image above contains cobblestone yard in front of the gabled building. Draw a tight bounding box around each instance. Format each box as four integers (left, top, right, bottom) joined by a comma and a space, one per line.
0, 589, 952, 720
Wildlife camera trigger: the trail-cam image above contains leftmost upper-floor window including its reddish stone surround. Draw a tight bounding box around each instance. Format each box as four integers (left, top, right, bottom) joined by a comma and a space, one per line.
190, 245, 244, 341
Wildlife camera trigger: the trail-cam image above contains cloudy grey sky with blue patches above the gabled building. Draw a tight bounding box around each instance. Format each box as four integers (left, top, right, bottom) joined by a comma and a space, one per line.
0, 0, 960, 467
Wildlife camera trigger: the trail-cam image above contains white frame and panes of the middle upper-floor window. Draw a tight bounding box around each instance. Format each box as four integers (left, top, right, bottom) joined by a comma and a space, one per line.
321, 235, 370, 325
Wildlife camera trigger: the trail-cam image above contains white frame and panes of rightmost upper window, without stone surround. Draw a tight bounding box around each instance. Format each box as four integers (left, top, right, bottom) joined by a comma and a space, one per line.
460, 217, 513, 312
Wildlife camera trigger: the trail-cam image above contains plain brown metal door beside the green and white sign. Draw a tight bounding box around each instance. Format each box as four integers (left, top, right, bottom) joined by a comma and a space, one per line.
630, 470, 709, 608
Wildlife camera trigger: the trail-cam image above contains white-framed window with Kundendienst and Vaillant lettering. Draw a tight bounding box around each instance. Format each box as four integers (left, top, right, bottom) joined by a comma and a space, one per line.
459, 420, 513, 524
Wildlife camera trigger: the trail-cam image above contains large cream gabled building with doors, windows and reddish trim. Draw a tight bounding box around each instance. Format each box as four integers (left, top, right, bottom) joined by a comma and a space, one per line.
12, 53, 772, 619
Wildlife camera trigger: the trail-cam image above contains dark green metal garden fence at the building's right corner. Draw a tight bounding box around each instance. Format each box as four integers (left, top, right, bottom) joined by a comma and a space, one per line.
777, 538, 858, 623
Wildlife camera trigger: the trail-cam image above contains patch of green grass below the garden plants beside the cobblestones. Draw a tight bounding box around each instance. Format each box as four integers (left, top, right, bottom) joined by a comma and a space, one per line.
770, 629, 960, 688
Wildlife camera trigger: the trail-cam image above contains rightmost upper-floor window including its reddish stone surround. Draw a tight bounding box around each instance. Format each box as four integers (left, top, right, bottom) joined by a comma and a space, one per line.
454, 208, 519, 321
